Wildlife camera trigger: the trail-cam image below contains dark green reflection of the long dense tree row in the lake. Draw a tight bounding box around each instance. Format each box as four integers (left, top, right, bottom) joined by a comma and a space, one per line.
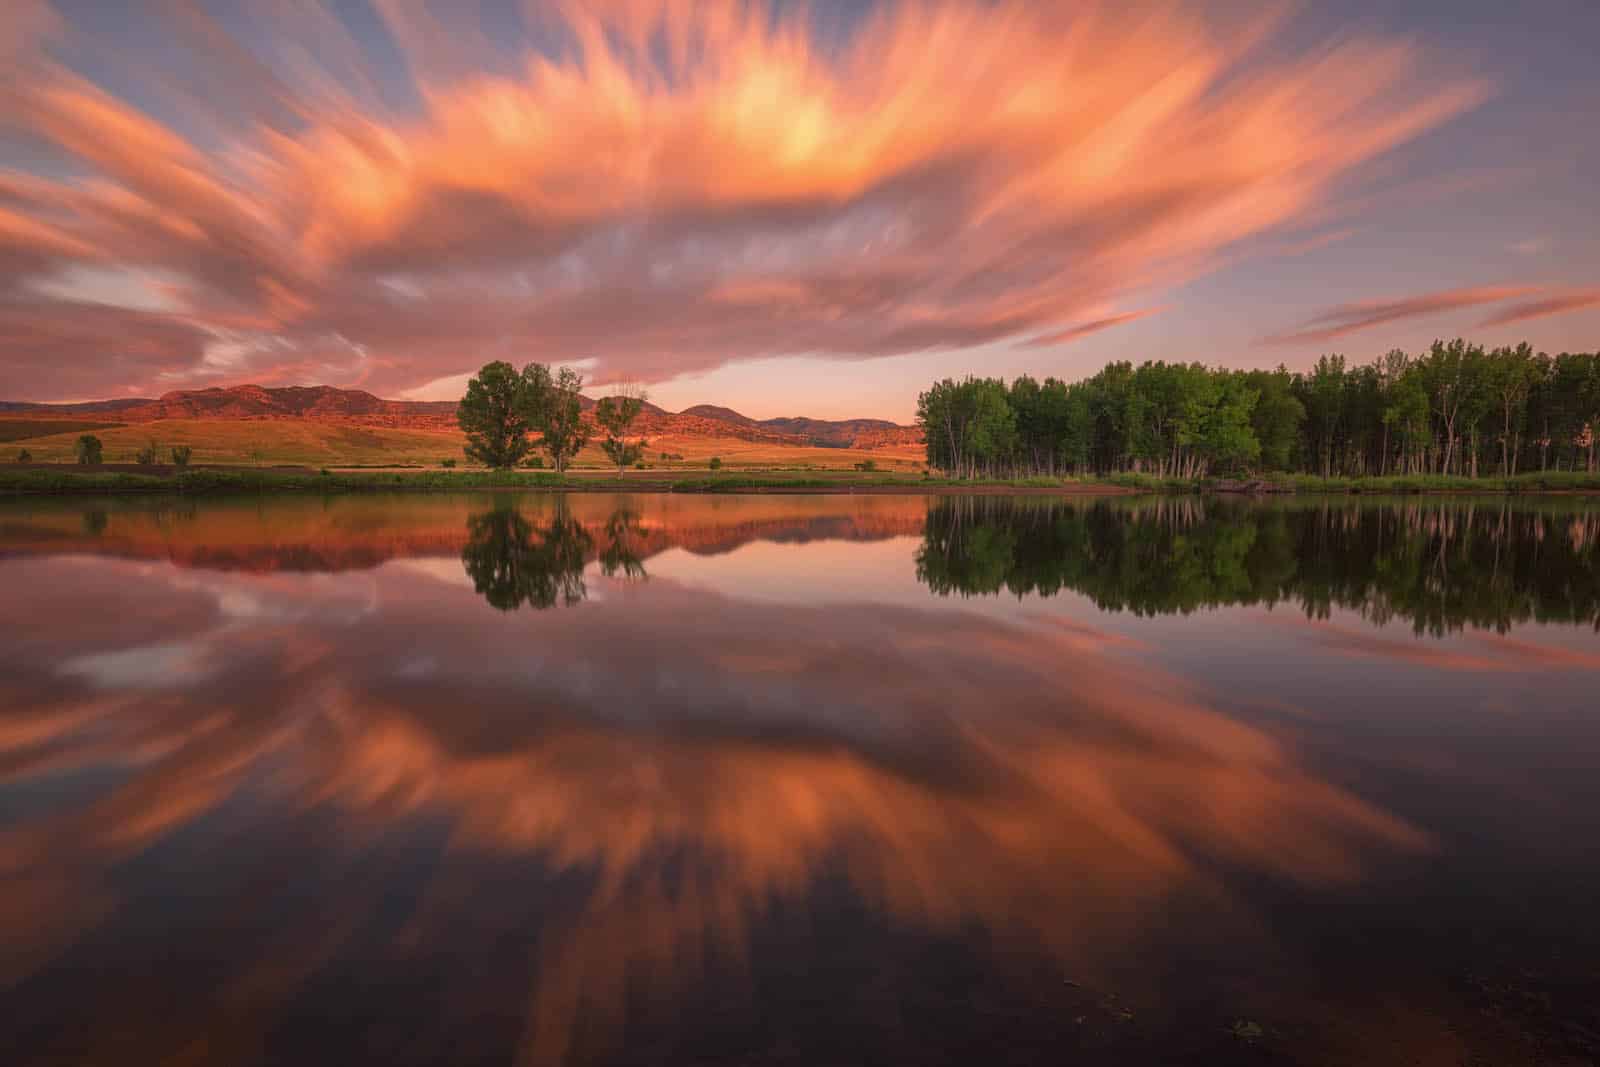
917, 498, 1600, 635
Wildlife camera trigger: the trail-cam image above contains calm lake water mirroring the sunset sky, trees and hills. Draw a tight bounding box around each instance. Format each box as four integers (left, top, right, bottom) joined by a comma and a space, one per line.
0, 494, 1600, 1065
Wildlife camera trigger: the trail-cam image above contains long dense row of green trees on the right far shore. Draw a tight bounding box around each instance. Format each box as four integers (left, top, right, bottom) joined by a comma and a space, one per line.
917, 339, 1600, 478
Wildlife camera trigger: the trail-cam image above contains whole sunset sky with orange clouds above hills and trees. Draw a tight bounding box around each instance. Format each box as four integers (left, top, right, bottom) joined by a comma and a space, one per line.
0, 0, 1600, 421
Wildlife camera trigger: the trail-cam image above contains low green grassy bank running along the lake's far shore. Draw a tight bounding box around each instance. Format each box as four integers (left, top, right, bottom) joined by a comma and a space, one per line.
0, 464, 1600, 494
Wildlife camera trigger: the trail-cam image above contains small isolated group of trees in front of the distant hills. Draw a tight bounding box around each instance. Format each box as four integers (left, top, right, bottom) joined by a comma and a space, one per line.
456, 360, 648, 474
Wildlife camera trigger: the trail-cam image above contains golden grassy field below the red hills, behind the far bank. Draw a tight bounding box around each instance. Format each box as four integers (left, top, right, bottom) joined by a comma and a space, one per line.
0, 418, 922, 472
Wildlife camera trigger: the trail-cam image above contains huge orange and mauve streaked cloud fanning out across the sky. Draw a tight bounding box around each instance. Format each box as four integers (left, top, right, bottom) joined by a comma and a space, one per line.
0, 0, 1485, 397
